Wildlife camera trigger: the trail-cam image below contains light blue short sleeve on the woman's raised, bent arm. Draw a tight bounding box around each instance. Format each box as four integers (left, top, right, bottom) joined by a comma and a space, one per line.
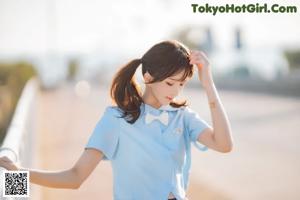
184, 107, 210, 151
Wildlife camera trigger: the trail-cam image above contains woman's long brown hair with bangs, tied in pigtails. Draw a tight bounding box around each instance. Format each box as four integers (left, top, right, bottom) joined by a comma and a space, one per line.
110, 40, 193, 124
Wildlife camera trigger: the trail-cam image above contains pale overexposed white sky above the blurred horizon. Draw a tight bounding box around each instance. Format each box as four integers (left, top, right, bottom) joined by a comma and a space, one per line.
0, 0, 300, 55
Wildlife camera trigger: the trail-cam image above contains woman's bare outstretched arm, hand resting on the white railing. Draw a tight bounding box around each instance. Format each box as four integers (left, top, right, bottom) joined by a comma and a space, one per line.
0, 148, 103, 189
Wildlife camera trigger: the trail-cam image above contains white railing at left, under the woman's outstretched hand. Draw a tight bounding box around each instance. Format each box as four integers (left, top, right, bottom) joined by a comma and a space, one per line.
0, 78, 38, 200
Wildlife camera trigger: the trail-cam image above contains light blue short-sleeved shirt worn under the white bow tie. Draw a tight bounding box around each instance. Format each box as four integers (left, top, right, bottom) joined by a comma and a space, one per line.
85, 103, 209, 200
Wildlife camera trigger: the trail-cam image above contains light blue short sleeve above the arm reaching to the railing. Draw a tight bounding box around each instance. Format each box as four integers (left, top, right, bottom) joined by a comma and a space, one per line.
85, 106, 120, 160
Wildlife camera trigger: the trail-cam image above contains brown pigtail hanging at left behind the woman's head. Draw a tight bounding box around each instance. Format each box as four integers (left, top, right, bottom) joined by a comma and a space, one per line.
110, 59, 143, 124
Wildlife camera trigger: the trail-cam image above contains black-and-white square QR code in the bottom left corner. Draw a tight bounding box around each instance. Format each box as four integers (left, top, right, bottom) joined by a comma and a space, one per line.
3, 171, 29, 197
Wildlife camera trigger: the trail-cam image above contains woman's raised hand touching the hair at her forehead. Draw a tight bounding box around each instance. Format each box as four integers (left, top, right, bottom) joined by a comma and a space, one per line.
190, 51, 213, 89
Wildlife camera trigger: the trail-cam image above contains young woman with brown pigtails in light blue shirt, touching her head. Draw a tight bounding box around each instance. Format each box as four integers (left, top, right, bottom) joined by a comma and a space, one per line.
0, 41, 233, 200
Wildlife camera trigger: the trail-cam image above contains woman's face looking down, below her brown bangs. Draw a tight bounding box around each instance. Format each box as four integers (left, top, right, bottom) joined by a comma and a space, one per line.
147, 71, 189, 105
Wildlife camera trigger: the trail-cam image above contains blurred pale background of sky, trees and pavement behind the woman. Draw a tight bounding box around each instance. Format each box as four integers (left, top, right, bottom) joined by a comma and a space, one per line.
0, 0, 300, 199
